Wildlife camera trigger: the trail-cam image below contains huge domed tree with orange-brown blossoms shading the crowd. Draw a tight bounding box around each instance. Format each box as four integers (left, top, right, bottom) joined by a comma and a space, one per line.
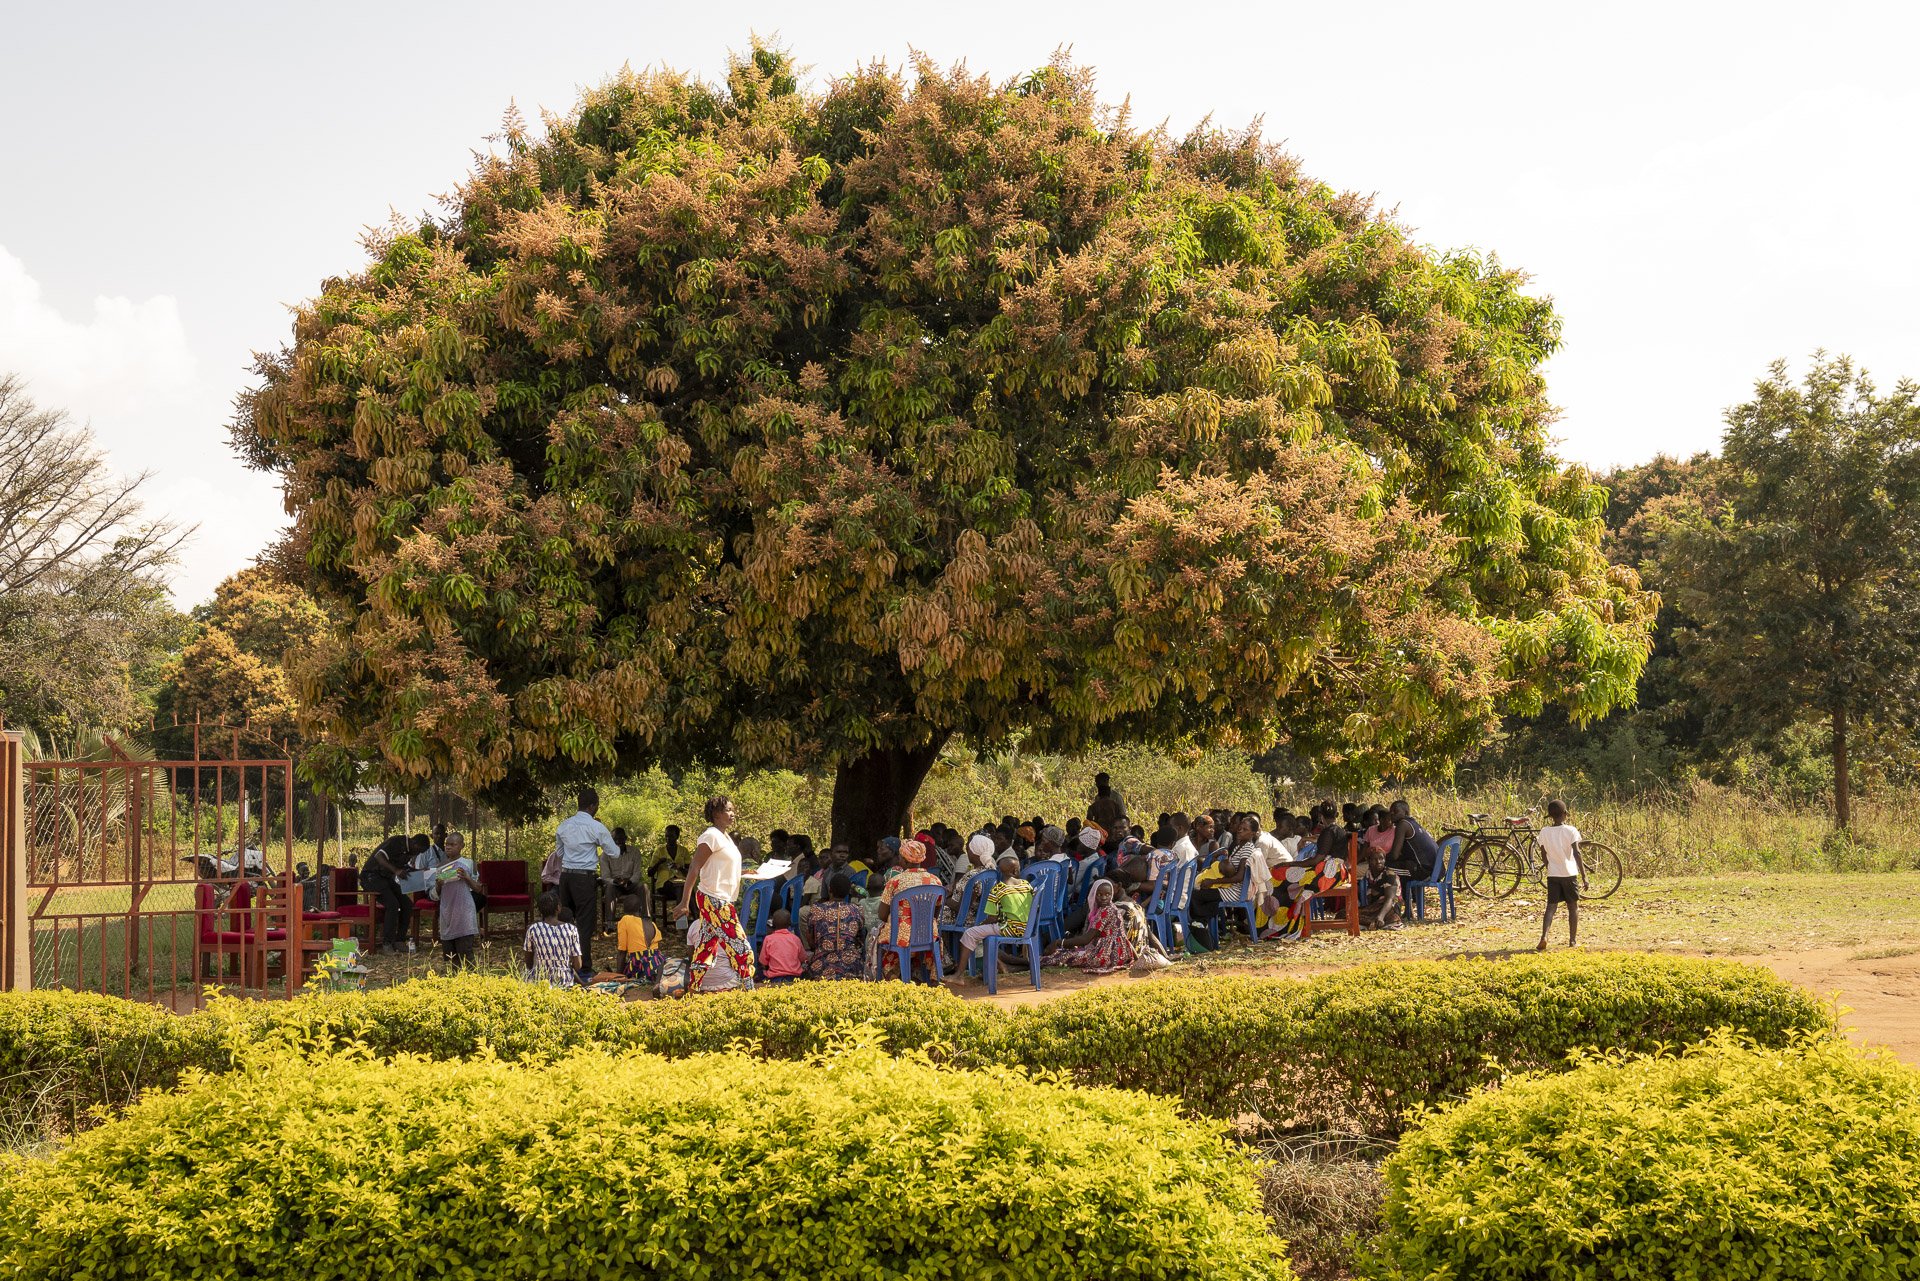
234, 48, 1653, 835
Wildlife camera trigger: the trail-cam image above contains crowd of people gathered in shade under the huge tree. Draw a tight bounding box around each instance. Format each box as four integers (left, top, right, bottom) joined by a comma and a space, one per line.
363, 774, 1440, 995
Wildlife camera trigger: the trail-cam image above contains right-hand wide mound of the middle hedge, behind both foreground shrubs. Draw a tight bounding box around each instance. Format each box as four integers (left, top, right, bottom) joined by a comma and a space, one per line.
1008, 953, 1832, 1137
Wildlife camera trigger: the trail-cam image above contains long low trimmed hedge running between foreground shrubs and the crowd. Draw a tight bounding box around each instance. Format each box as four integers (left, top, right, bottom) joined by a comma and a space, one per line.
0, 953, 1832, 1137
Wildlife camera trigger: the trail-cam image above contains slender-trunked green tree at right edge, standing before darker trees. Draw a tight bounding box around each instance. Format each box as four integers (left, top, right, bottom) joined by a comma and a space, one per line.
1661, 357, 1920, 828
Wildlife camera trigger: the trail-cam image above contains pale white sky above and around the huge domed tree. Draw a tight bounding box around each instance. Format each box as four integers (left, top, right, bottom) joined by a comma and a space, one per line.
0, 0, 1920, 605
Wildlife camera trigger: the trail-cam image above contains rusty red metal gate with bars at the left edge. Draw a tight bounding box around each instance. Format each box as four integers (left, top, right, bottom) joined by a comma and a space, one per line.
0, 734, 294, 1006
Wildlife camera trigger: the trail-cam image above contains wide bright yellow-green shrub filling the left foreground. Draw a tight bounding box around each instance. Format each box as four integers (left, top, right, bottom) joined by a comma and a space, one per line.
0, 1045, 1290, 1281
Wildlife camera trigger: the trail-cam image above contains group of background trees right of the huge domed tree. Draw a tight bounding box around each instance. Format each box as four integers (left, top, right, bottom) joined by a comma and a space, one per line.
1469, 355, 1920, 826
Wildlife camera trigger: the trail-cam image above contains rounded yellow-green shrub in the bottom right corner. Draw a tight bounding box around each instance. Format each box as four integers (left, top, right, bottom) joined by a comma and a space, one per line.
1373, 1037, 1920, 1281
